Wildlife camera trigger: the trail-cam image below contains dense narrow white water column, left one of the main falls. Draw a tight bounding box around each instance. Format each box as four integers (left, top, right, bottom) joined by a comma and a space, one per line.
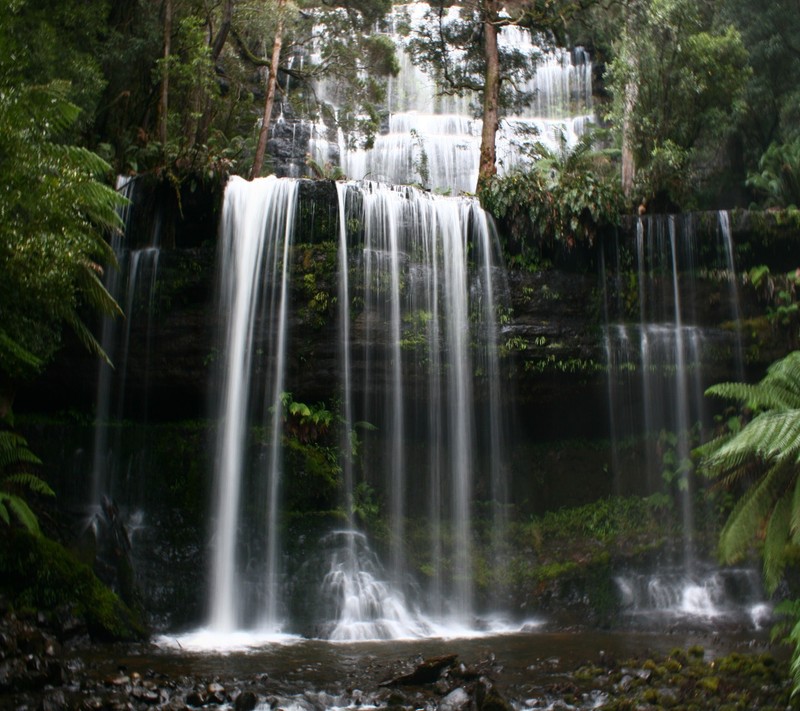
210, 177, 297, 633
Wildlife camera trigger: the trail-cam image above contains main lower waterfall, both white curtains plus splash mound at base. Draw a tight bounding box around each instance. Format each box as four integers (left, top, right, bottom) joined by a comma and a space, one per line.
203, 178, 507, 640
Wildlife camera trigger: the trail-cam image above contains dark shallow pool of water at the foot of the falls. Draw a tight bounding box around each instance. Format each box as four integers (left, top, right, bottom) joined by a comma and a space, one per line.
72, 626, 783, 708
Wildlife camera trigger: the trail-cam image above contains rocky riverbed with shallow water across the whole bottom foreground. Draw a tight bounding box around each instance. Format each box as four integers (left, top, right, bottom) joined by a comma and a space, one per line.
0, 600, 800, 711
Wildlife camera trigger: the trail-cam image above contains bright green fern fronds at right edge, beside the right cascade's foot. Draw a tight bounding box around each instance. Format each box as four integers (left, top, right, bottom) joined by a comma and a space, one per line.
697, 351, 800, 590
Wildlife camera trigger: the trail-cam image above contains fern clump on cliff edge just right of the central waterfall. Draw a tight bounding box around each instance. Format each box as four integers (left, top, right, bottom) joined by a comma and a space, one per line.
480, 135, 622, 266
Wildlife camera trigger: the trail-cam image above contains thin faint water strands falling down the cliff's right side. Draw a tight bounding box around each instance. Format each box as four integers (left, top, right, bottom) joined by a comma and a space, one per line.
602, 213, 741, 570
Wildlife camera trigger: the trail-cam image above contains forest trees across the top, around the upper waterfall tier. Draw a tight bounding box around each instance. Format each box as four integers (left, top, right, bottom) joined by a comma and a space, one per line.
3, 0, 800, 208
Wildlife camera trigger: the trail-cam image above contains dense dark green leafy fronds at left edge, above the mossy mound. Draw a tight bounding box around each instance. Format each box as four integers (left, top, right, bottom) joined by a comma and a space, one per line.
0, 77, 123, 379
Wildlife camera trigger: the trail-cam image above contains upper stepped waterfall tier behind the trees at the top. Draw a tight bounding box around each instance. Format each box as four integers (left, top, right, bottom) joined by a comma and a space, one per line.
309, 3, 592, 193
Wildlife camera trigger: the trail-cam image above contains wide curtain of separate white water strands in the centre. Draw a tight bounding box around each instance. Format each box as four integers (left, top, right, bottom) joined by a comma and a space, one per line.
336, 184, 504, 625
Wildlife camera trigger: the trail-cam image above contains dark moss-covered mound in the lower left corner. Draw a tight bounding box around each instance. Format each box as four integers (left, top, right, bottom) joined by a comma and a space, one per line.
0, 529, 146, 642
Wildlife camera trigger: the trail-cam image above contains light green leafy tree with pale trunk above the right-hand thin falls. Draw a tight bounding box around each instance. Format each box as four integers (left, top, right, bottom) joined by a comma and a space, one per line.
608, 0, 750, 205
